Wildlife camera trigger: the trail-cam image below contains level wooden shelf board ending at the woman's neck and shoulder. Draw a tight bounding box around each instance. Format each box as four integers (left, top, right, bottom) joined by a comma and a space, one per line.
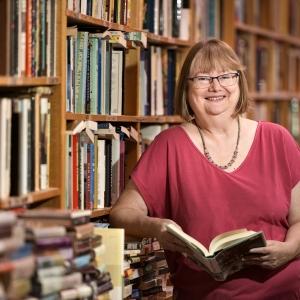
66, 113, 183, 123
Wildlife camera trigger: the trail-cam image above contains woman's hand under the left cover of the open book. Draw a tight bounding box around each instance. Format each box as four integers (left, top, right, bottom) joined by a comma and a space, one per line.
155, 219, 193, 254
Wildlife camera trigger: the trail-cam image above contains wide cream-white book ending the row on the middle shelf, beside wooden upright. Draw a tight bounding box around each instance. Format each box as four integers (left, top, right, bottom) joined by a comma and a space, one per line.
110, 50, 123, 116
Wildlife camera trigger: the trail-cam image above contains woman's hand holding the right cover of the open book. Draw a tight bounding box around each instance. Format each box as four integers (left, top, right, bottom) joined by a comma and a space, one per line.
243, 240, 294, 269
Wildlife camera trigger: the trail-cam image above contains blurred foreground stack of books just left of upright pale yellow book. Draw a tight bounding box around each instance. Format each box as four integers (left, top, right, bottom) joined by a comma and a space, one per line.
19, 208, 110, 299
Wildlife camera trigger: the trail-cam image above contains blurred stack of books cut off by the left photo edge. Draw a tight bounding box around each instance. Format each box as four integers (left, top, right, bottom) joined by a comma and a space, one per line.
0, 212, 35, 299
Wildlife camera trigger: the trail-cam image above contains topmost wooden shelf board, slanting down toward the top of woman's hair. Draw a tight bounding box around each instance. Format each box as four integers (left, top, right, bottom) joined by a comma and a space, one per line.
66, 9, 194, 47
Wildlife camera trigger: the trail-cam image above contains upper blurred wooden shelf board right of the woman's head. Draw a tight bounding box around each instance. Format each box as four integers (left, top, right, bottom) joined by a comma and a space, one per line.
235, 22, 300, 46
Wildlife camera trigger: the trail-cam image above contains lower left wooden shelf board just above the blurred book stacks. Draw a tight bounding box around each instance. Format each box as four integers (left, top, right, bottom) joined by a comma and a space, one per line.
0, 188, 60, 209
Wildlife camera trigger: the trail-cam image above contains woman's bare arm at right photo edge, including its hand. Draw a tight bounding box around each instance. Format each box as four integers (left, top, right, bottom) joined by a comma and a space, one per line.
243, 182, 300, 269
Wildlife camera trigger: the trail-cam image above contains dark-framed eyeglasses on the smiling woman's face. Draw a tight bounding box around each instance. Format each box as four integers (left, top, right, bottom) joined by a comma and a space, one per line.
188, 73, 239, 89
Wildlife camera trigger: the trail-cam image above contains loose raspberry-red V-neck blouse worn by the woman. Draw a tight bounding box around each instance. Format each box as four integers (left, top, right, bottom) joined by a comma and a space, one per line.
131, 122, 300, 300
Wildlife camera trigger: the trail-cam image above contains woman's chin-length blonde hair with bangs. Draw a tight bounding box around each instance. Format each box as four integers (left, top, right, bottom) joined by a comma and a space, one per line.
174, 39, 252, 121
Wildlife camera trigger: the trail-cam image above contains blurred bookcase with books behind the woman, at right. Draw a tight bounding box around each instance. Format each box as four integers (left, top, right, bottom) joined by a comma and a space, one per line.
227, 0, 300, 143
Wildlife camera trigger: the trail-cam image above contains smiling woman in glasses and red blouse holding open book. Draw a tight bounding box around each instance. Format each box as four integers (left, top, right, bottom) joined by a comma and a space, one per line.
110, 39, 300, 300
